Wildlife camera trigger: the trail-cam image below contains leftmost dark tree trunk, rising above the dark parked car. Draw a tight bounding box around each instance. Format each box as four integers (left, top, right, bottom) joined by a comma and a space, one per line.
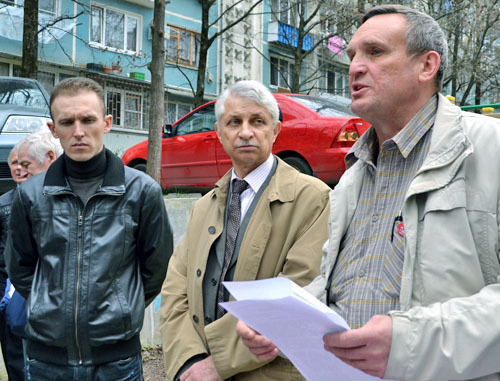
21, 0, 38, 79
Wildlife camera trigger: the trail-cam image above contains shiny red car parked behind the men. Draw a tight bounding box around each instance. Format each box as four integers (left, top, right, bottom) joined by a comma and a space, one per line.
122, 93, 370, 189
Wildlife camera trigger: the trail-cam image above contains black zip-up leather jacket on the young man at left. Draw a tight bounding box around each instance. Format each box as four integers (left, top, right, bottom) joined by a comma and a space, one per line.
5, 151, 173, 365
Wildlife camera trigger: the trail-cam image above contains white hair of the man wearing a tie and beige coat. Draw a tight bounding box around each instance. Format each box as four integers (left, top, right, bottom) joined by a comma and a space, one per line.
215, 80, 280, 127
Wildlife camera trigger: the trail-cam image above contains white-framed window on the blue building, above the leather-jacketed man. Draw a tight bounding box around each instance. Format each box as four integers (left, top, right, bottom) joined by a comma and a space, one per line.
89, 2, 143, 56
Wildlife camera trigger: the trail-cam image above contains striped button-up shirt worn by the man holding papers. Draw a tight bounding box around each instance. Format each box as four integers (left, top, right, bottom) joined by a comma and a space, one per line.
329, 96, 437, 328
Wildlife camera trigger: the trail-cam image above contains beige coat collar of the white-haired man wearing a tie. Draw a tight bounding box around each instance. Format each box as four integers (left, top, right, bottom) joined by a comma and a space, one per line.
210, 156, 300, 202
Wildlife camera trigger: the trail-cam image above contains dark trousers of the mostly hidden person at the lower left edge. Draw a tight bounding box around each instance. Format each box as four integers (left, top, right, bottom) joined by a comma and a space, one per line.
0, 313, 24, 381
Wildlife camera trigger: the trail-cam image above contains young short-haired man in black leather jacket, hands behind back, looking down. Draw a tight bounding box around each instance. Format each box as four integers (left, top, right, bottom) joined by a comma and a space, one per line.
5, 78, 173, 381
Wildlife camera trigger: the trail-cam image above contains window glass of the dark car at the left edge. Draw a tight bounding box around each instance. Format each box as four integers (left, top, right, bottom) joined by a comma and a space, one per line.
0, 80, 48, 109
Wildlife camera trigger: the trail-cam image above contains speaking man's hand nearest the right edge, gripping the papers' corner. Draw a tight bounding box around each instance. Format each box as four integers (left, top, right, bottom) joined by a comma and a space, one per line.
323, 315, 392, 377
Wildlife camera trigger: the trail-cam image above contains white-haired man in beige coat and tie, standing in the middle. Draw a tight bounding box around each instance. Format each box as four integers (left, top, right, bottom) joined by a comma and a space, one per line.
161, 81, 329, 380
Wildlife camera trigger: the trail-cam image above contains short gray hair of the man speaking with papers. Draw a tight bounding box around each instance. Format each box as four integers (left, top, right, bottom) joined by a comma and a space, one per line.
361, 4, 448, 91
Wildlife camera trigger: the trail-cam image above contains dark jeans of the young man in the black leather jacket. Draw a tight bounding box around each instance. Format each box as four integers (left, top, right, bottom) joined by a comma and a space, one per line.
26, 354, 143, 381
